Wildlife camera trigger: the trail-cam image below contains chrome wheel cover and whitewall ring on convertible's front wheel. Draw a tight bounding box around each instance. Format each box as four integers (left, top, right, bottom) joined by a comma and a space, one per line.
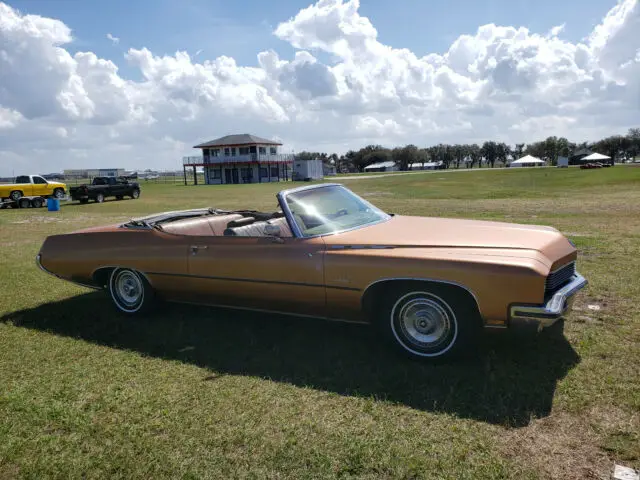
391, 292, 458, 357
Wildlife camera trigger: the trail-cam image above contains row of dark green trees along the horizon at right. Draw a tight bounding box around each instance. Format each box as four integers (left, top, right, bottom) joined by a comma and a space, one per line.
296, 128, 640, 172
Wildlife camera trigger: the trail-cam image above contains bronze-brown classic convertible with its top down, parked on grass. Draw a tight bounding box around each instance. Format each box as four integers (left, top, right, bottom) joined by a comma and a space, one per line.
37, 184, 587, 359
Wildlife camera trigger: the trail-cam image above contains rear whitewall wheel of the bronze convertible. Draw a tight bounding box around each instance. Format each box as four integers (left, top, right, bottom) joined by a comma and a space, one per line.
109, 268, 154, 315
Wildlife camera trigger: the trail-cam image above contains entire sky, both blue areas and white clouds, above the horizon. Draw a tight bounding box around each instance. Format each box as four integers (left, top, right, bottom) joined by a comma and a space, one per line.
0, 0, 640, 176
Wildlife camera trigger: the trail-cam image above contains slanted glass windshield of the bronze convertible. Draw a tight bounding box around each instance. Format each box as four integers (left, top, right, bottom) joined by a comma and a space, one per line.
285, 185, 390, 237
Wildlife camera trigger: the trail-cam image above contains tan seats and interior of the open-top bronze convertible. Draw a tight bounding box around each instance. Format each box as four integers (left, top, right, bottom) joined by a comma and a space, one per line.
162, 213, 293, 237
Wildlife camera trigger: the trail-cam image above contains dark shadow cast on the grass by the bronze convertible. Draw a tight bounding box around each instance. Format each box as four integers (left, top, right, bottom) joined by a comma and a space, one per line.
0, 292, 579, 427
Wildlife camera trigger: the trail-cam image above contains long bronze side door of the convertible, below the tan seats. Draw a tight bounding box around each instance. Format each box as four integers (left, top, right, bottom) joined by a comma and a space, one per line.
188, 236, 326, 316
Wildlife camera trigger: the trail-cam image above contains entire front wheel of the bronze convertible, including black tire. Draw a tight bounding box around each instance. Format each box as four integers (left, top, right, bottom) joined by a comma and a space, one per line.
377, 285, 481, 361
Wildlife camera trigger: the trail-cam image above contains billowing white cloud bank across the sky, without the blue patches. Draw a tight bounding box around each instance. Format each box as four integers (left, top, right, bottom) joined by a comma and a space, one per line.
0, 0, 640, 175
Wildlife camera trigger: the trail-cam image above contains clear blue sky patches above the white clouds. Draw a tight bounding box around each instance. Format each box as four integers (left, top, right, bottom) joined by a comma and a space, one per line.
9, 0, 615, 78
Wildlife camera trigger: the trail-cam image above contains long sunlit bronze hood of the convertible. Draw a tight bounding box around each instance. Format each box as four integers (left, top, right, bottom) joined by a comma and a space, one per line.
324, 215, 575, 258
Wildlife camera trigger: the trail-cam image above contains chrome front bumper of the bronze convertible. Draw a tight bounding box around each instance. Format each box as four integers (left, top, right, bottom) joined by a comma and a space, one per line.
509, 272, 589, 330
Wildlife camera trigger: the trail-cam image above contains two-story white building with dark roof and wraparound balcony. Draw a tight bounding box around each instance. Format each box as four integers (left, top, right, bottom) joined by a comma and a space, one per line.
182, 133, 293, 185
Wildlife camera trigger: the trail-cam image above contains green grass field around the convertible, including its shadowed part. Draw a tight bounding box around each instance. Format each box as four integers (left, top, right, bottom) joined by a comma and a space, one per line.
0, 166, 640, 479
